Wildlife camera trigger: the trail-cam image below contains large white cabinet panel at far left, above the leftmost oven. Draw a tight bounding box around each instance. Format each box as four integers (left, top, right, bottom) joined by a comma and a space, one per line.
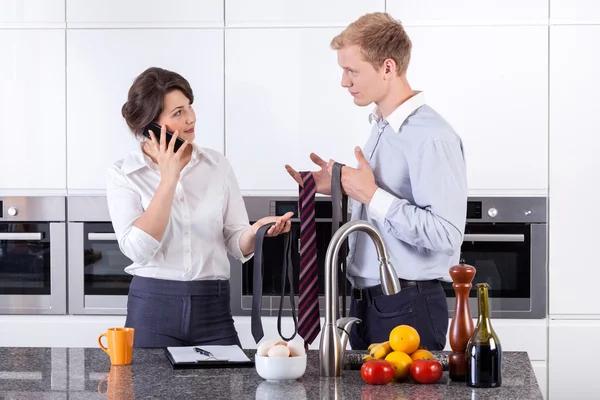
0, 30, 66, 191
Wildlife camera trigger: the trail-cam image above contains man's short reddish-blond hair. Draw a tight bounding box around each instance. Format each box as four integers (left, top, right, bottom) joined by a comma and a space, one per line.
331, 12, 412, 75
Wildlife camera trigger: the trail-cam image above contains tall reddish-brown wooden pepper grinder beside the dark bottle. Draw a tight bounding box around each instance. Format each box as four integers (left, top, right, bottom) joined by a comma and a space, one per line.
448, 260, 477, 382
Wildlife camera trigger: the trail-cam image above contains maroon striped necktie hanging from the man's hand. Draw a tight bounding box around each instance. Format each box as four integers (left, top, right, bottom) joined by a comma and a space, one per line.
298, 171, 321, 345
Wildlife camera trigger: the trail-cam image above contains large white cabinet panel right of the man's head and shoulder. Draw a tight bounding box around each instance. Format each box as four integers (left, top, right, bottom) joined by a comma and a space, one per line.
407, 26, 548, 191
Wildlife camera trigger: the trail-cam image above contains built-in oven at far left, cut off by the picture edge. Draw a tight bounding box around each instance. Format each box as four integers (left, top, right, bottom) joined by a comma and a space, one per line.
0, 196, 67, 314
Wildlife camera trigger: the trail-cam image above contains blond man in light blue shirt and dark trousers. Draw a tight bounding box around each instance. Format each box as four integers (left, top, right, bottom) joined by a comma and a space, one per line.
286, 13, 467, 350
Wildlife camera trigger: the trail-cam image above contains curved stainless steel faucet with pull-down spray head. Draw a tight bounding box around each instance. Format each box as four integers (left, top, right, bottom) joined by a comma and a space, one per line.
319, 220, 400, 377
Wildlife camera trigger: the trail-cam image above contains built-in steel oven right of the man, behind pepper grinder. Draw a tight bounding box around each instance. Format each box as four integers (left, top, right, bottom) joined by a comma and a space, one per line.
443, 197, 548, 319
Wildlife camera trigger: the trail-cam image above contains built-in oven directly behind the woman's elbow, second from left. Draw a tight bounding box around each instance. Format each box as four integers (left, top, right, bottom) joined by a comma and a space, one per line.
67, 196, 132, 315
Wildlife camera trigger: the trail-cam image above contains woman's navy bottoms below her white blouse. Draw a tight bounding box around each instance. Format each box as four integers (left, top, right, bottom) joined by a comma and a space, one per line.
125, 276, 241, 347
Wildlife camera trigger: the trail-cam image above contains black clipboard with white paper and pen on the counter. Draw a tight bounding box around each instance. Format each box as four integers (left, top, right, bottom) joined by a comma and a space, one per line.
165, 345, 254, 369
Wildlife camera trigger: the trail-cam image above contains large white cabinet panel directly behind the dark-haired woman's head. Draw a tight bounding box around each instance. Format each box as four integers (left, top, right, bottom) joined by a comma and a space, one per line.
67, 29, 224, 190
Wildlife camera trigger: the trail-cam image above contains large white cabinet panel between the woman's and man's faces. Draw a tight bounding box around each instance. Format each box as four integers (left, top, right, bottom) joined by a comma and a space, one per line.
225, 29, 371, 193
